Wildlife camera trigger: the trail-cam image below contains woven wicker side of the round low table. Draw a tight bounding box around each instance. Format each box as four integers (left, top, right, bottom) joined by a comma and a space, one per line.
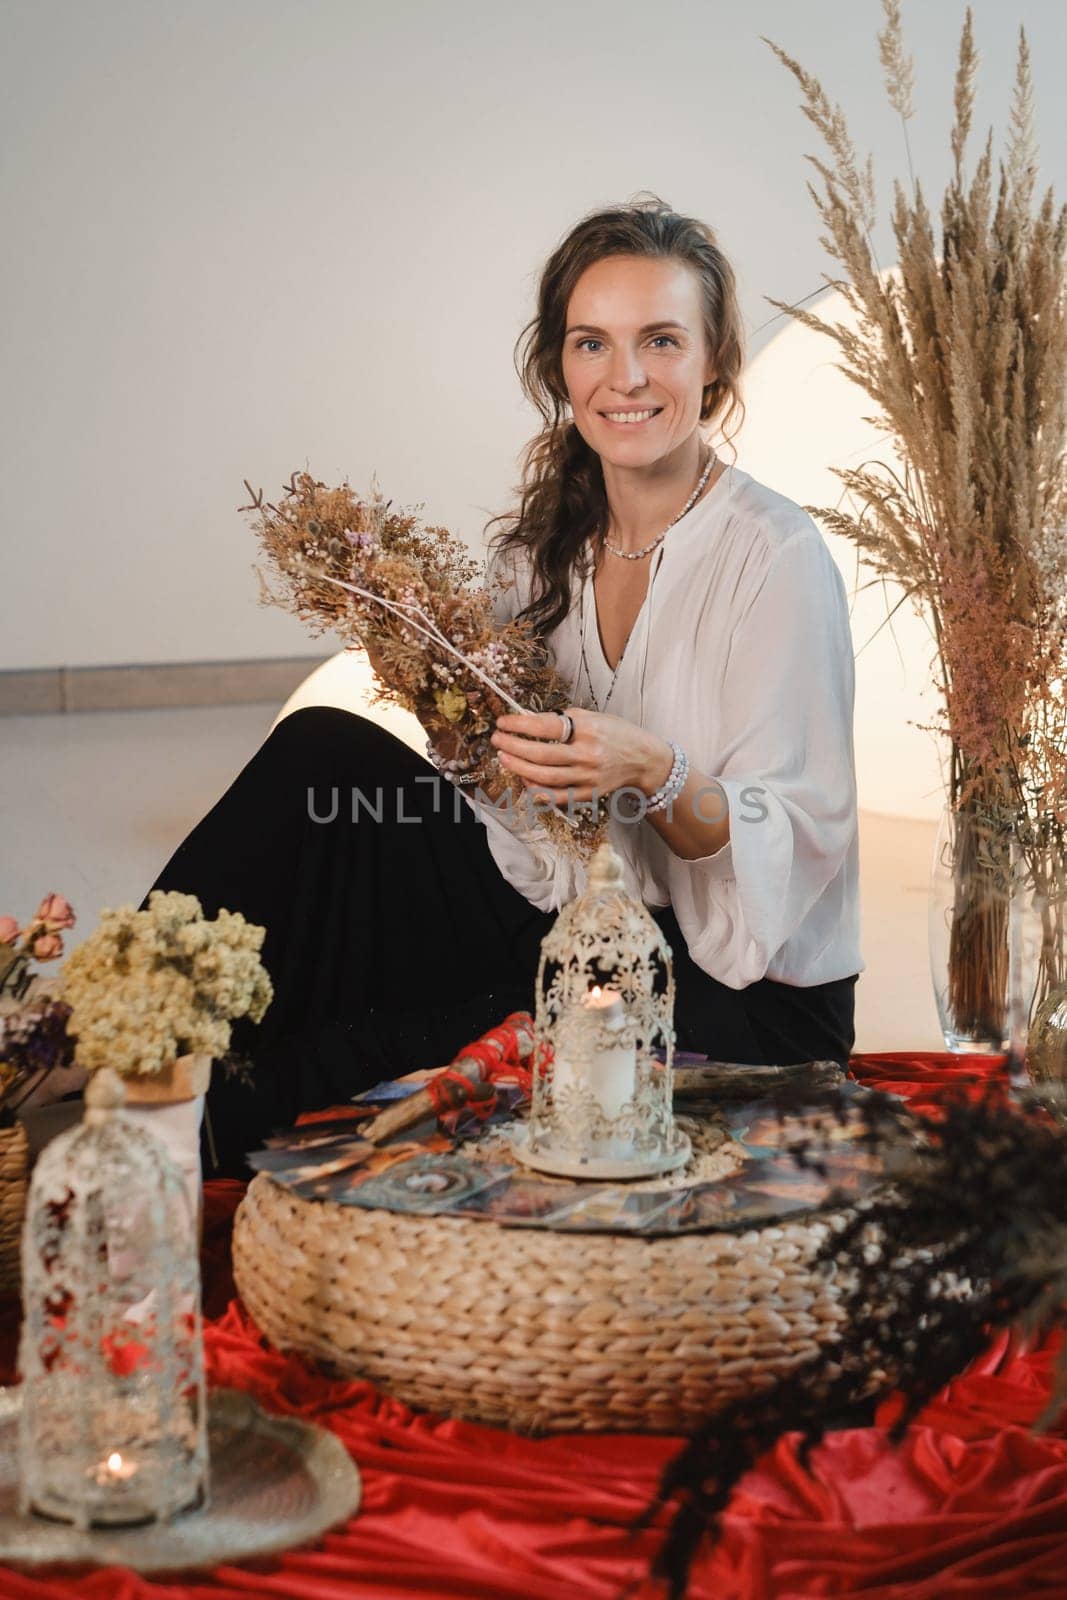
234, 1173, 843, 1434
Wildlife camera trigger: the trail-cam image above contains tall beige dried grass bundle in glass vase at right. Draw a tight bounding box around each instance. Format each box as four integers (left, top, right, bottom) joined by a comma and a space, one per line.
766, 0, 1067, 1037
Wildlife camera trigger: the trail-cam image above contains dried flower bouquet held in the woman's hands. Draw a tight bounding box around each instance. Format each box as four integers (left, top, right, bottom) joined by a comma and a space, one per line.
240, 472, 606, 859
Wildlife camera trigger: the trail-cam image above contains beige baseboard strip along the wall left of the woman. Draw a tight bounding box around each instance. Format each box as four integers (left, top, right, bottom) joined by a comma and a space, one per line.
0, 656, 330, 717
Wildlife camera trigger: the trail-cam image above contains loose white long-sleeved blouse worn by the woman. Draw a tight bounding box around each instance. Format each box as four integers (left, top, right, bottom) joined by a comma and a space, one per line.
459, 467, 865, 989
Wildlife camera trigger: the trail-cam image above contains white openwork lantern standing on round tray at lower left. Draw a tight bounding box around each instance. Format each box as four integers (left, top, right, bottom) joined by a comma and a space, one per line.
19, 1070, 208, 1528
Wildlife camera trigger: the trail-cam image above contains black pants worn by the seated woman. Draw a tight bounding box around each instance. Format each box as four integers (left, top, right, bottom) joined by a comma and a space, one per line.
146, 707, 856, 1173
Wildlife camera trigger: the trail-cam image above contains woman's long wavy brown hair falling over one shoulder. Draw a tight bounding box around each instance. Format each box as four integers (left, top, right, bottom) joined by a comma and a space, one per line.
486, 192, 744, 638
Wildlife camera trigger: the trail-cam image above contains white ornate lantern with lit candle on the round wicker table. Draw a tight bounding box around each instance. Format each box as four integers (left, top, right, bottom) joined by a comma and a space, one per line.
515, 843, 691, 1179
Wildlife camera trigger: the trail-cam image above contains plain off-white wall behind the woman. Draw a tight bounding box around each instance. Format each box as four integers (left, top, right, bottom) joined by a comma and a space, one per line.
0, 0, 1067, 691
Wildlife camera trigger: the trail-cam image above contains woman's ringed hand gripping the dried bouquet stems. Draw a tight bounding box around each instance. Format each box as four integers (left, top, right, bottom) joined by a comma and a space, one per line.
491, 706, 673, 805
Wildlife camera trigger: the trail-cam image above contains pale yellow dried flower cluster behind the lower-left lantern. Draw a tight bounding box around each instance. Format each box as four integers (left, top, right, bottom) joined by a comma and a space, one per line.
61, 890, 274, 1077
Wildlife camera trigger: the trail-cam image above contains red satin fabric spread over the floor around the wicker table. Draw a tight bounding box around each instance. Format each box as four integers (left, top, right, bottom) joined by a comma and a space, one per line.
0, 1054, 1067, 1600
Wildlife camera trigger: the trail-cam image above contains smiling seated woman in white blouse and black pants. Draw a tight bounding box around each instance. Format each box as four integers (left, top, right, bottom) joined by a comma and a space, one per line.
143, 198, 864, 1170
